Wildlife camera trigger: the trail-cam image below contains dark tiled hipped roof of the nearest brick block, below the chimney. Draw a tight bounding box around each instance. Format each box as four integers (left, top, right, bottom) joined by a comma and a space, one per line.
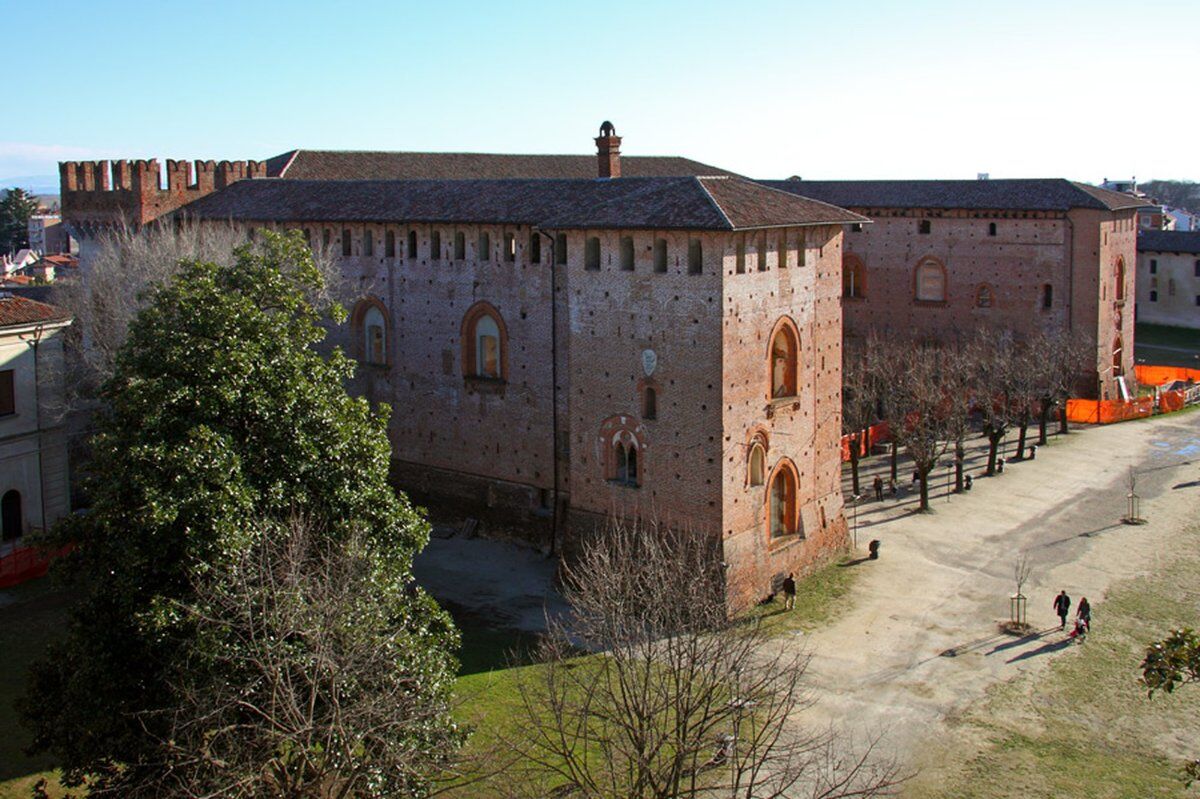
180, 176, 866, 230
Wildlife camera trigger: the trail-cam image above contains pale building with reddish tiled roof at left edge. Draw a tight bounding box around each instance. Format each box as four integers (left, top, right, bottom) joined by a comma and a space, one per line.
0, 294, 71, 546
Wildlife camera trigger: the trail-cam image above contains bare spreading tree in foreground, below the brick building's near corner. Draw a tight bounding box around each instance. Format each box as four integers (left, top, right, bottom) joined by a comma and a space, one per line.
510, 523, 898, 799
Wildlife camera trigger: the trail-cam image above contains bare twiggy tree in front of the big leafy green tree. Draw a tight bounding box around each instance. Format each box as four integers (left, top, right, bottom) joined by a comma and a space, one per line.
117, 519, 462, 799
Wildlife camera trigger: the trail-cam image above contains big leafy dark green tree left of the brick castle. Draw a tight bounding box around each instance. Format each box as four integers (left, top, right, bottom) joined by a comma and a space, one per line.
22, 233, 460, 797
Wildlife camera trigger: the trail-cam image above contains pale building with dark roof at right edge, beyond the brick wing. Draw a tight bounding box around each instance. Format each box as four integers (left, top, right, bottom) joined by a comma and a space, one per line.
1138, 230, 1200, 329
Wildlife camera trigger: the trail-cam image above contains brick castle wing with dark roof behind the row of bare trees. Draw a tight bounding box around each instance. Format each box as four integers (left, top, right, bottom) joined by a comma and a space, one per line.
766, 179, 1146, 397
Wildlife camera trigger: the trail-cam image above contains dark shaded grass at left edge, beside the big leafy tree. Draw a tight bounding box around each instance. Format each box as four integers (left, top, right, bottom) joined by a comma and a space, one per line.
0, 578, 70, 799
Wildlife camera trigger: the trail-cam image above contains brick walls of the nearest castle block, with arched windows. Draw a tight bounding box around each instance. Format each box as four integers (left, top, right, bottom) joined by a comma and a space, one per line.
64, 155, 853, 607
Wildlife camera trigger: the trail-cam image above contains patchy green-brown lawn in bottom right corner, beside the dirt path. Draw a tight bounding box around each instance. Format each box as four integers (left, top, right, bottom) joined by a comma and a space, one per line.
905, 528, 1200, 799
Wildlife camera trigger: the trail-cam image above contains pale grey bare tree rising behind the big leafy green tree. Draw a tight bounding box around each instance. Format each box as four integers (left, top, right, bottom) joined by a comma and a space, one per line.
52, 220, 348, 410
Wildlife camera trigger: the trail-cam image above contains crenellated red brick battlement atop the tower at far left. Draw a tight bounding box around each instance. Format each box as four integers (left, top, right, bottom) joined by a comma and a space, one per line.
59, 158, 266, 226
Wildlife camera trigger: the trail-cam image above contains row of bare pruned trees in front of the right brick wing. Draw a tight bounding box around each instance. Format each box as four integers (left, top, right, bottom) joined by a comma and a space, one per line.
842, 330, 1087, 510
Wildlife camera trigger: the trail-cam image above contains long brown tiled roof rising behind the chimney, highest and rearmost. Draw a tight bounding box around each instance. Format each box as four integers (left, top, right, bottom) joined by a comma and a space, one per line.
266, 150, 733, 180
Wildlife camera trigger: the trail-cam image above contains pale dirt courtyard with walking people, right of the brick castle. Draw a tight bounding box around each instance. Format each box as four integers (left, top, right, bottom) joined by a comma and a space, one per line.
796, 411, 1200, 765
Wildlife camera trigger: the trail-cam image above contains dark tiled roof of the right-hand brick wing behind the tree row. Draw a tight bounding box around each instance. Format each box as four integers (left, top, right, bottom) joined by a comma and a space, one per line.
761, 178, 1150, 211
